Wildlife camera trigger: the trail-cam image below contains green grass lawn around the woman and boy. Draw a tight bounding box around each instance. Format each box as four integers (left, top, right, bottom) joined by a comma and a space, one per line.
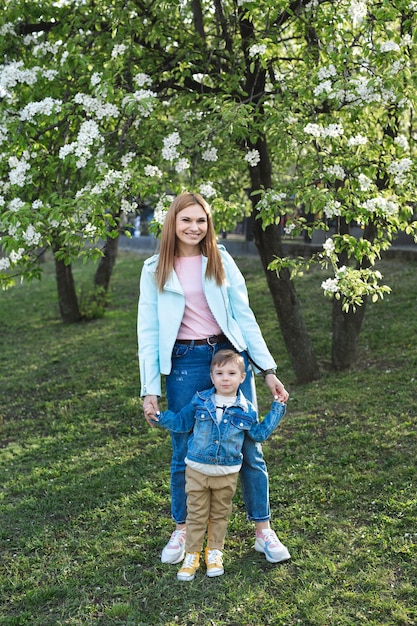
0, 253, 417, 626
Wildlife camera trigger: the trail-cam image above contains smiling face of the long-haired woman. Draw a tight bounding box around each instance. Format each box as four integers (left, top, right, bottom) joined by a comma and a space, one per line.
175, 204, 207, 256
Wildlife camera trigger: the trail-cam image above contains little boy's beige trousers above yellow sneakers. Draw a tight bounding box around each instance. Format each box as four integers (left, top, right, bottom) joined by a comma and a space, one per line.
185, 465, 239, 552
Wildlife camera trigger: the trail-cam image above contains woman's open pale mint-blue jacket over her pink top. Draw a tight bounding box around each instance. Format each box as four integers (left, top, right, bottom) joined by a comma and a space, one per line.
138, 244, 276, 396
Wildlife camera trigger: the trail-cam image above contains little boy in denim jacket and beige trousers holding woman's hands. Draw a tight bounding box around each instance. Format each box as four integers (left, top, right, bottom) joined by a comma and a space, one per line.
150, 350, 286, 581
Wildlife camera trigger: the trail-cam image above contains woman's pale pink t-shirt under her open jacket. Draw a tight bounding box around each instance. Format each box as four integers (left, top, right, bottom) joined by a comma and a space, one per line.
174, 255, 222, 339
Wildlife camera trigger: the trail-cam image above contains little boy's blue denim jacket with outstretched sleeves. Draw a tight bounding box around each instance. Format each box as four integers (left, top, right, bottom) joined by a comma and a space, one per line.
157, 387, 286, 465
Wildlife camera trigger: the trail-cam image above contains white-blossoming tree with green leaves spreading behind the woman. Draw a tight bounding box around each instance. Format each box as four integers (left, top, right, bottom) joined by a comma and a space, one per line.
0, 0, 417, 381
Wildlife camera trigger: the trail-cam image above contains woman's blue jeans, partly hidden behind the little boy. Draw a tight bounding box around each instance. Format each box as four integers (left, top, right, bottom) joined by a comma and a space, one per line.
166, 342, 270, 524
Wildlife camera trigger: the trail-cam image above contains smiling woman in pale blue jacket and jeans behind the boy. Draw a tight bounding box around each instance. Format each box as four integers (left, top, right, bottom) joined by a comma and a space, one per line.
138, 192, 290, 563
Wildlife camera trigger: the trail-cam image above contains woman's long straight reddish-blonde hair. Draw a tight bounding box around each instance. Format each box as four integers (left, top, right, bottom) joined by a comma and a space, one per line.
156, 191, 225, 291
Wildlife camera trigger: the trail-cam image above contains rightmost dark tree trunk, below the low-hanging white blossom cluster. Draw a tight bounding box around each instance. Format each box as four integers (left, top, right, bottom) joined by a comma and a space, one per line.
332, 298, 366, 371
